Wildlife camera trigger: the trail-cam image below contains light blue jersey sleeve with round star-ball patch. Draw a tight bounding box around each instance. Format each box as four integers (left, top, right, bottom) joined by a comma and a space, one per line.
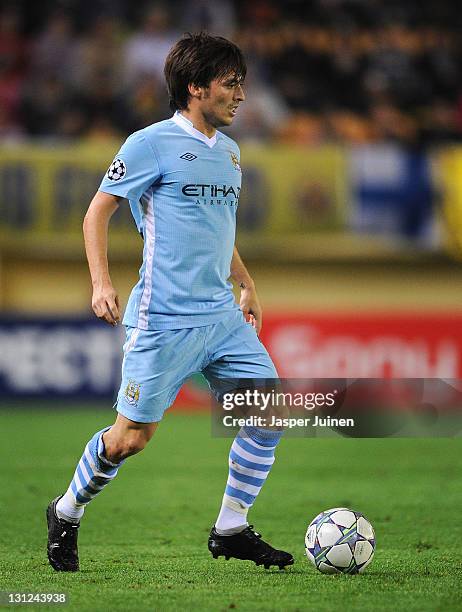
99, 132, 160, 200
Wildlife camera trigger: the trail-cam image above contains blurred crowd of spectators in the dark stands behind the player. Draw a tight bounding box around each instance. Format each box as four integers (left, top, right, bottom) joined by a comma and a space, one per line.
0, 0, 462, 146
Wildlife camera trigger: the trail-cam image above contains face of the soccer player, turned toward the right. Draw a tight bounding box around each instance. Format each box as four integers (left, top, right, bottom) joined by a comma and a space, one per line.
201, 75, 245, 128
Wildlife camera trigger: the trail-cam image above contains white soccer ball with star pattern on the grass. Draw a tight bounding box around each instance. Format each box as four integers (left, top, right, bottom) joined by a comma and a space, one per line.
305, 508, 375, 574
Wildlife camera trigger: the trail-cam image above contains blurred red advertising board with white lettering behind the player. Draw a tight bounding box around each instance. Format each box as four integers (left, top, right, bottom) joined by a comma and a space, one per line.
177, 311, 462, 407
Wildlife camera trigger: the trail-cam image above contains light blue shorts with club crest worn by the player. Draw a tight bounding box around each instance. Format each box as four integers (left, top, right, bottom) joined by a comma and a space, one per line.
117, 309, 278, 423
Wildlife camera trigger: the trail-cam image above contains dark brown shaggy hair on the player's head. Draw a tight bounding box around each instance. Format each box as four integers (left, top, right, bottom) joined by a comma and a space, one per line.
164, 32, 247, 110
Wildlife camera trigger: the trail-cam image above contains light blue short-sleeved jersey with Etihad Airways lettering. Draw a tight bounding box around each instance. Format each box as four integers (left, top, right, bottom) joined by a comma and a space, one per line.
99, 113, 241, 330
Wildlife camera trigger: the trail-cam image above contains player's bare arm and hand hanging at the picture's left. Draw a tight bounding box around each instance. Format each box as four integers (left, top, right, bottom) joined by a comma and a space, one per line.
83, 191, 122, 325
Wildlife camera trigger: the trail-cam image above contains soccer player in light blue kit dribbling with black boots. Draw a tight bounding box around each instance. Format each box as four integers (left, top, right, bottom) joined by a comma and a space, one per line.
47, 33, 293, 571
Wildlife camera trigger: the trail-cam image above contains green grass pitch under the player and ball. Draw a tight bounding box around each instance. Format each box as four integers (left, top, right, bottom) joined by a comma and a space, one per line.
0, 407, 462, 612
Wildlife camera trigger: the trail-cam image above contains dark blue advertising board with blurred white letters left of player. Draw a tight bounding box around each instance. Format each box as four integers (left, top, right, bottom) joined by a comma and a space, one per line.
0, 317, 124, 400
